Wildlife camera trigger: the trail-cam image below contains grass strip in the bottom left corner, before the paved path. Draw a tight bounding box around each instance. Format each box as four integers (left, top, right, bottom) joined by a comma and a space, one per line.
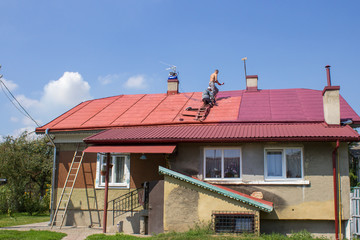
0, 230, 66, 240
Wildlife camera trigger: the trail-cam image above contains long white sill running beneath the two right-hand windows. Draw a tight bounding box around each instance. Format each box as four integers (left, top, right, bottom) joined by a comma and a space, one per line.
205, 180, 310, 185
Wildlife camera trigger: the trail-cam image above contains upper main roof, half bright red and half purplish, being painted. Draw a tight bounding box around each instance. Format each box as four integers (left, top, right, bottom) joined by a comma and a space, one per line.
36, 89, 360, 132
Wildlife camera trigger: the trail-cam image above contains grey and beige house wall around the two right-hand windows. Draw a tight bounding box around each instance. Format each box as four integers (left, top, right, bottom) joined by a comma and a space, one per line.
170, 142, 350, 220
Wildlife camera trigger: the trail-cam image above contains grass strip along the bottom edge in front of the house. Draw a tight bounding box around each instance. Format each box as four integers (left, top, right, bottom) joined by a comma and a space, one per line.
86, 228, 325, 240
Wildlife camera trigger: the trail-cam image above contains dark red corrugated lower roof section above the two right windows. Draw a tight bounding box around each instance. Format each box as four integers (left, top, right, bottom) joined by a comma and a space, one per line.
84, 123, 360, 144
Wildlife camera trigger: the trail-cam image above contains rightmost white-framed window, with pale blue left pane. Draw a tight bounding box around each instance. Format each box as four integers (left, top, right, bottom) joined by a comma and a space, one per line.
265, 148, 303, 180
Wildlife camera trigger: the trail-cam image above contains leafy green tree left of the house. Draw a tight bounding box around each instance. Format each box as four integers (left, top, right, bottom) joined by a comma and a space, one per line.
0, 132, 52, 214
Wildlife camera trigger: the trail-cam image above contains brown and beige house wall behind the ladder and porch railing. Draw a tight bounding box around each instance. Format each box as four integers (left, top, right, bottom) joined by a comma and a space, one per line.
54, 143, 166, 233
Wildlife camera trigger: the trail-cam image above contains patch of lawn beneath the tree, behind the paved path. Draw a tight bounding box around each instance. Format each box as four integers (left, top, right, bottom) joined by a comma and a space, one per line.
0, 213, 49, 227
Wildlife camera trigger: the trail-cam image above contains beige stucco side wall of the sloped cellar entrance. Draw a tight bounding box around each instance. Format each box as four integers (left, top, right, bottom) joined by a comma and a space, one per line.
164, 176, 259, 232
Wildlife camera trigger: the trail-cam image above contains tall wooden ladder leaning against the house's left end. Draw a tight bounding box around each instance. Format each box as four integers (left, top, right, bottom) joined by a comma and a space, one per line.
51, 145, 85, 228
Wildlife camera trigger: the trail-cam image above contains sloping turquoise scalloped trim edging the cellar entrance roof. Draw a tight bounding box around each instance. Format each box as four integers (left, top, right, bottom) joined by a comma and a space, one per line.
159, 166, 273, 212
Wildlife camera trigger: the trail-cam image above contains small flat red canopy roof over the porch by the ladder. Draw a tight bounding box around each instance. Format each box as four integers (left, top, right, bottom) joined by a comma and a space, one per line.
84, 145, 176, 153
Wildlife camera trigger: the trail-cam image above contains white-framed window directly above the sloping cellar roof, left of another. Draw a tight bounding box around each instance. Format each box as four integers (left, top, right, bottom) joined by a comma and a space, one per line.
204, 148, 241, 179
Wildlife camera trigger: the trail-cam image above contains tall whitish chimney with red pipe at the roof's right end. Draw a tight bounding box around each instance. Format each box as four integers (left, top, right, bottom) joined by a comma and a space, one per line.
322, 65, 340, 125
